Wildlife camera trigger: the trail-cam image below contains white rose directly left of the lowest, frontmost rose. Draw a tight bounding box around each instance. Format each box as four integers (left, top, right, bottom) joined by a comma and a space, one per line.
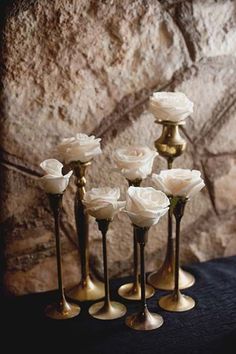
83, 187, 125, 220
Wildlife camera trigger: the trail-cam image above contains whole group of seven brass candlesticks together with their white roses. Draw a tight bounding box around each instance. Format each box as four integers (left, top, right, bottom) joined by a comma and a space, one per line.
40, 92, 204, 330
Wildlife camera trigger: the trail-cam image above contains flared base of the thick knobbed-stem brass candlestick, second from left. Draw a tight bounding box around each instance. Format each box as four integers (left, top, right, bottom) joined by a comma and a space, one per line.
67, 277, 105, 301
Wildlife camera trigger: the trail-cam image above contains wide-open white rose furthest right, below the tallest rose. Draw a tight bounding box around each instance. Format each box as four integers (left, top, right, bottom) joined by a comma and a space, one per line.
152, 168, 205, 198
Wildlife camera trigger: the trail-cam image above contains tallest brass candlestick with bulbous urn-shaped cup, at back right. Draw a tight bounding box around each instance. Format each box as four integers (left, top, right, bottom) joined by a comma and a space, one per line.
148, 120, 195, 290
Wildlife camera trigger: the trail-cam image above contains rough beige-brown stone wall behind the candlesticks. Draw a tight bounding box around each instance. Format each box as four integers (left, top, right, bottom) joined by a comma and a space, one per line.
1, 0, 236, 294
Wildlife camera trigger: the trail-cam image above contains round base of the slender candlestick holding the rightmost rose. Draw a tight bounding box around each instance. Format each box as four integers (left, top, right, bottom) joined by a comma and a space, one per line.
159, 292, 195, 312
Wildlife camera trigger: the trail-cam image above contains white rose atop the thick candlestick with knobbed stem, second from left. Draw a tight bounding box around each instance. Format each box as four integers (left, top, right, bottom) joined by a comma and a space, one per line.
57, 134, 102, 163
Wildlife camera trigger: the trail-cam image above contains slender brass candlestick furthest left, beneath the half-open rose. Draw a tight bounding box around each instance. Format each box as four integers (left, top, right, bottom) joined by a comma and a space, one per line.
45, 194, 80, 320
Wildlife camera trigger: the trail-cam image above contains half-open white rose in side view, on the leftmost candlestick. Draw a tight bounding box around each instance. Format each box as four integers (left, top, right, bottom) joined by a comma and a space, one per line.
40, 159, 73, 194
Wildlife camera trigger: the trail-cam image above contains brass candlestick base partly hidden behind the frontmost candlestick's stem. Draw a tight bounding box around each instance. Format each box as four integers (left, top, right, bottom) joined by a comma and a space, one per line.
118, 283, 155, 301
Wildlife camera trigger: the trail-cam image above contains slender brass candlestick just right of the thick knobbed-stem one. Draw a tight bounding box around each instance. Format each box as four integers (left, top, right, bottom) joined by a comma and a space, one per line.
89, 220, 127, 320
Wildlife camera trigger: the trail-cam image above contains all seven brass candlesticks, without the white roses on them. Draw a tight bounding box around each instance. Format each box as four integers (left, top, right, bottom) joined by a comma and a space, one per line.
41, 120, 201, 330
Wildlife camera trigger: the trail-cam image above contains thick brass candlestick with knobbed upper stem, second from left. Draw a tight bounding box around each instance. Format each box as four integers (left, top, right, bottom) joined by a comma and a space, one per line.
68, 162, 105, 301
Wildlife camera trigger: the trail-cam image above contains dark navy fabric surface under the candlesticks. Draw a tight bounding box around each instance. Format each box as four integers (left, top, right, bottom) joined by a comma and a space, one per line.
0, 257, 236, 354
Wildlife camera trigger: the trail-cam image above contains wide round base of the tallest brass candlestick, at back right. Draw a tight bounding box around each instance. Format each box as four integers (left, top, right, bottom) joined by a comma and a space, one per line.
148, 263, 195, 290
